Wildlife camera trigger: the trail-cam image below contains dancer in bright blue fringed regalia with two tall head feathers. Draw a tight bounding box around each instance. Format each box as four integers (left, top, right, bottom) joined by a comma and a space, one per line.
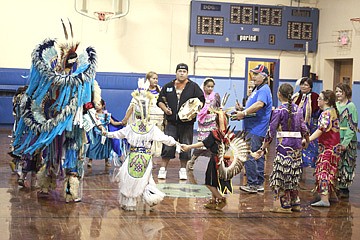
13, 19, 97, 202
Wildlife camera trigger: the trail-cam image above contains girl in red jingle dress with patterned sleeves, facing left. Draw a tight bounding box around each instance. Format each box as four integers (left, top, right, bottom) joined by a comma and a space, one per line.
309, 90, 340, 207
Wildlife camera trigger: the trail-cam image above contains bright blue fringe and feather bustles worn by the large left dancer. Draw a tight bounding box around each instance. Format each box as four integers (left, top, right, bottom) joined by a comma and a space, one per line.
13, 39, 96, 175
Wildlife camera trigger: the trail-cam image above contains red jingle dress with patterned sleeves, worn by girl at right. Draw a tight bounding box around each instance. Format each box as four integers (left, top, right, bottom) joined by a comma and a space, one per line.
315, 108, 340, 195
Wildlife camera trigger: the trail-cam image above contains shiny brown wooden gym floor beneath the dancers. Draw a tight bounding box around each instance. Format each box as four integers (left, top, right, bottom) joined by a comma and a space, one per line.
0, 126, 360, 240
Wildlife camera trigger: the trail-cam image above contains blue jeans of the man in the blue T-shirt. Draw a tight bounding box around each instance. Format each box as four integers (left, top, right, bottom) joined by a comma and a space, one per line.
245, 133, 265, 186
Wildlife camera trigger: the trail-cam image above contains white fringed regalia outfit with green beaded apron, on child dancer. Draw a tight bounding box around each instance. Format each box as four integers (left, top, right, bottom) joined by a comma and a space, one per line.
106, 120, 176, 210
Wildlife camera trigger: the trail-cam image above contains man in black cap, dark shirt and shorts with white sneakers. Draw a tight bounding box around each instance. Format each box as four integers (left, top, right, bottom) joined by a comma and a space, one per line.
157, 63, 205, 180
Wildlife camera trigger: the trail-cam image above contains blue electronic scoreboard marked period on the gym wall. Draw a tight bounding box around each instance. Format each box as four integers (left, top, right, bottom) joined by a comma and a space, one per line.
190, 1, 319, 52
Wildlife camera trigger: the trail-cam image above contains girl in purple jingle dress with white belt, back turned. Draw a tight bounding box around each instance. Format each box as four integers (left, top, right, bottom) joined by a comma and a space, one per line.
257, 83, 309, 213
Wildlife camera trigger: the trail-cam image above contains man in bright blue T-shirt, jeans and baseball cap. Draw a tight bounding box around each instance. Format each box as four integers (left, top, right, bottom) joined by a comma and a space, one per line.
236, 64, 272, 193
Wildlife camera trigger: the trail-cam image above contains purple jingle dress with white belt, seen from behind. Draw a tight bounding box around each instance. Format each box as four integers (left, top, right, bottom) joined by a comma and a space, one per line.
265, 103, 309, 192
